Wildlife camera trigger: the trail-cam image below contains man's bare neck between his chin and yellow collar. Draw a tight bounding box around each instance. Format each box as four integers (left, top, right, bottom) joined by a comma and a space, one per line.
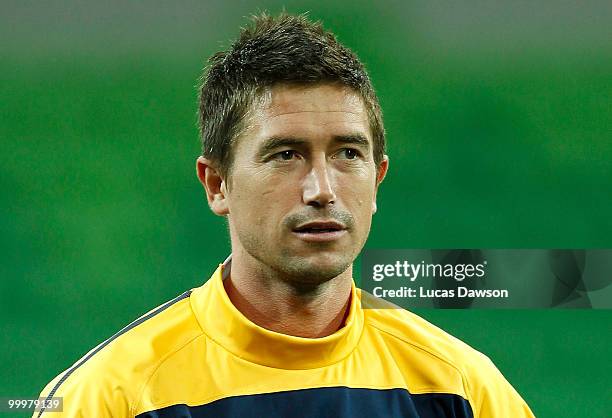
223, 250, 352, 338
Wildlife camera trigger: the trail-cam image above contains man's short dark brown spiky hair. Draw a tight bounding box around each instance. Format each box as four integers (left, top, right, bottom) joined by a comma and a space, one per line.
198, 12, 385, 176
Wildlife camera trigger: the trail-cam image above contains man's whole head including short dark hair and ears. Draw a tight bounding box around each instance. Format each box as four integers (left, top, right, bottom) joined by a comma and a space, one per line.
198, 14, 388, 283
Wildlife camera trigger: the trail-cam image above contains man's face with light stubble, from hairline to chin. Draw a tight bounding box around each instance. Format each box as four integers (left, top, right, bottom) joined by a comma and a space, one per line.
213, 84, 387, 284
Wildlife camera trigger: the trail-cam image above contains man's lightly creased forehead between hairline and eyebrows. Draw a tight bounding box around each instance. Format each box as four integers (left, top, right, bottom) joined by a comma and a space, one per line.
249, 84, 371, 144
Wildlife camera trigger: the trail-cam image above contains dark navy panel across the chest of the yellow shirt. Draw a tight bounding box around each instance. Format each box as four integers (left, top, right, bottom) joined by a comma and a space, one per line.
136, 386, 473, 418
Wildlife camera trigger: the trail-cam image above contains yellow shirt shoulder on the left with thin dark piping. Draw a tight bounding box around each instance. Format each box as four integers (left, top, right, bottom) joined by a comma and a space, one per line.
34, 291, 202, 416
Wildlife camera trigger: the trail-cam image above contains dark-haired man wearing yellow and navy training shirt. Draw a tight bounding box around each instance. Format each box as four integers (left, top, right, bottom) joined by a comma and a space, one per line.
34, 14, 533, 418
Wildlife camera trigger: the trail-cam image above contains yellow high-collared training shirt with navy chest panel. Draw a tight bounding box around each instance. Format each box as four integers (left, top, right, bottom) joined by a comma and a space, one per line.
33, 265, 533, 418
